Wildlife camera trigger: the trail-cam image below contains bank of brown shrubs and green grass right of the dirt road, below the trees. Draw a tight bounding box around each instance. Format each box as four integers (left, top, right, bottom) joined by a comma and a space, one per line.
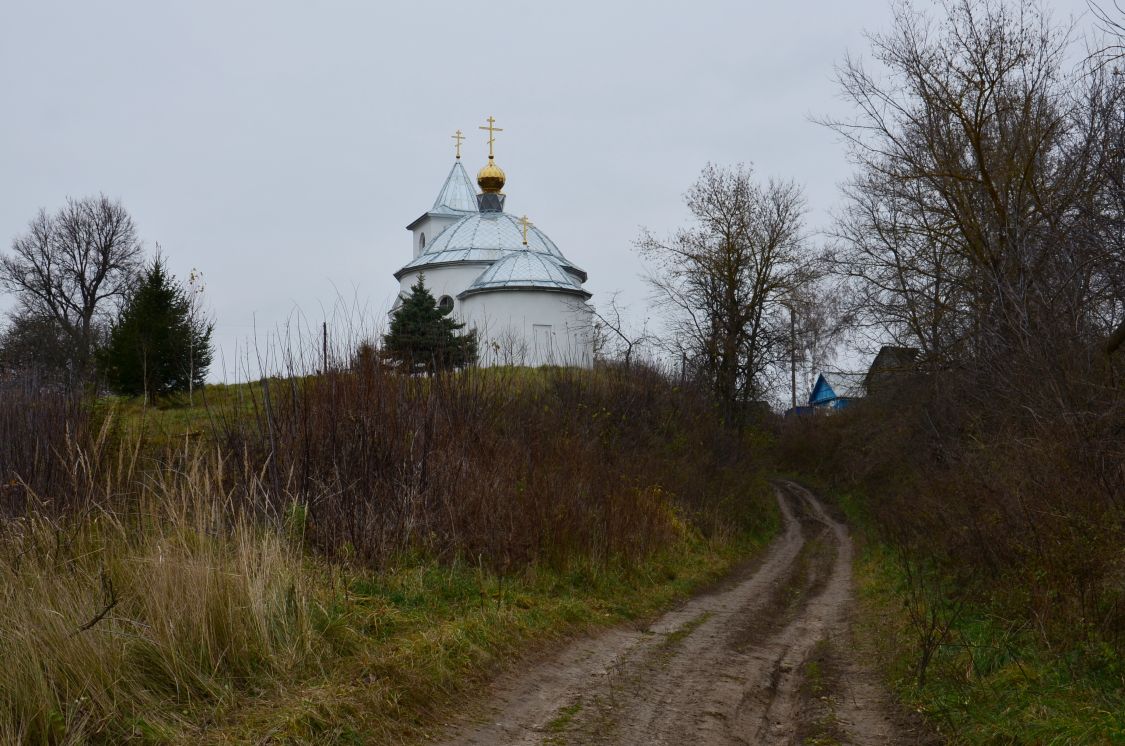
779, 374, 1125, 743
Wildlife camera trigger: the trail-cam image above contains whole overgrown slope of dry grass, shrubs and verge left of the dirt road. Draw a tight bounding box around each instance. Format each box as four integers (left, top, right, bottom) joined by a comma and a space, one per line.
0, 360, 776, 743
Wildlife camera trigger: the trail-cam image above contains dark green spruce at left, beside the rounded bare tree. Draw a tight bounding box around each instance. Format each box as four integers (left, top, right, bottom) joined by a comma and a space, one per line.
100, 257, 214, 398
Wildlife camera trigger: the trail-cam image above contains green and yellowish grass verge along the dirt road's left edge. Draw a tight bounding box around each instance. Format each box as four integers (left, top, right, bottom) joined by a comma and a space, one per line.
192, 528, 767, 743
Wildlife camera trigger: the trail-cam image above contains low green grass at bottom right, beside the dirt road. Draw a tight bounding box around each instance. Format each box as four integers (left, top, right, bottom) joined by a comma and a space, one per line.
856, 546, 1125, 744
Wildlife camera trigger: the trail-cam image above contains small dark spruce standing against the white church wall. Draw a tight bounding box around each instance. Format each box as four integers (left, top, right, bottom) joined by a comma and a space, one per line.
383, 275, 477, 374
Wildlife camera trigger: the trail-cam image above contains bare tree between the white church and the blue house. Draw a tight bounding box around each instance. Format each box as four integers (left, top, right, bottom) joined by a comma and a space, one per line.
637, 164, 815, 414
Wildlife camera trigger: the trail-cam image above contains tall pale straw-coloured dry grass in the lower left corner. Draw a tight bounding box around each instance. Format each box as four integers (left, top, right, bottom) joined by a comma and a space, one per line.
0, 445, 317, 743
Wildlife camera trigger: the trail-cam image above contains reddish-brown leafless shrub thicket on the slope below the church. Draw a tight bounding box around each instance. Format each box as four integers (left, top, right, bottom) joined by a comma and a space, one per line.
214, 361, 771, 565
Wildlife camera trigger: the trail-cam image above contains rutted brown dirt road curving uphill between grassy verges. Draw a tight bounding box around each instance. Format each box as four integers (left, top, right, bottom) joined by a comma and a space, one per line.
448, 483, 934, 746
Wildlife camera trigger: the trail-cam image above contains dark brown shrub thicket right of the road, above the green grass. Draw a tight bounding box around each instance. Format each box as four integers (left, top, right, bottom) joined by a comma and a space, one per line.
780, 358, 1125, 680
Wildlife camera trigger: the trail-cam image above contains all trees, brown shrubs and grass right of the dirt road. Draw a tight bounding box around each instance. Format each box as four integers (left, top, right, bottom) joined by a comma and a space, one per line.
780, 0, 1125, 743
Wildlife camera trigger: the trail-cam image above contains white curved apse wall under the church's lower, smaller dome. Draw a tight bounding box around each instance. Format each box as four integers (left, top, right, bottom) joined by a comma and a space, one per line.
460, 289, 593, 368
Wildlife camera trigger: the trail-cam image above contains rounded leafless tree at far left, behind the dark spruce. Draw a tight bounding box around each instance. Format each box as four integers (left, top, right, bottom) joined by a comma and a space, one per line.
0, 195, 142, 377
